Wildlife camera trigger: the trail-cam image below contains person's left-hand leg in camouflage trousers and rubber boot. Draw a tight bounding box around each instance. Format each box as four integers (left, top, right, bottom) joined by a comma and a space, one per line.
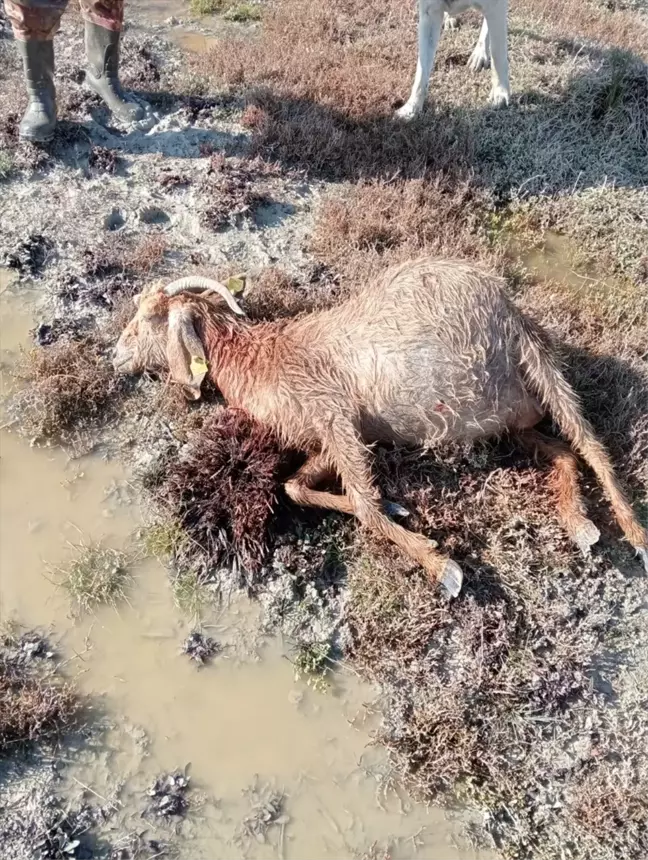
5, 0, 67, 143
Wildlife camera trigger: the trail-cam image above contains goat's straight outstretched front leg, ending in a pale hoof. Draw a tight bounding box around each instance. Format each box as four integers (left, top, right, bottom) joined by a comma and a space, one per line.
325, 416, 463, 597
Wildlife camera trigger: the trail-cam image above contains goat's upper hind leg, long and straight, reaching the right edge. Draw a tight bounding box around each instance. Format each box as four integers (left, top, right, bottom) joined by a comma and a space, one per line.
519, 317, 648, 556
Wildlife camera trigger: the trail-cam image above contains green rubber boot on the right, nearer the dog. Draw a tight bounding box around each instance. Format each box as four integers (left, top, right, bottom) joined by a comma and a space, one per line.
85, 21, 144, 122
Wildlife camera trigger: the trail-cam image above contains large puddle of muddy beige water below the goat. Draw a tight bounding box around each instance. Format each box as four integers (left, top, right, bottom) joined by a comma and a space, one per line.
0, 286, 476, 860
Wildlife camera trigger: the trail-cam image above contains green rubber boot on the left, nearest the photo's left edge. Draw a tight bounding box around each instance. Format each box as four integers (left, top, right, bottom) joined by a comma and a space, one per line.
16, 39, 56, 143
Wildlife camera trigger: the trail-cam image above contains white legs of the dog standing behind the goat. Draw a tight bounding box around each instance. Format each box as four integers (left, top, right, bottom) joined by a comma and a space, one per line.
396, 0, 510, 119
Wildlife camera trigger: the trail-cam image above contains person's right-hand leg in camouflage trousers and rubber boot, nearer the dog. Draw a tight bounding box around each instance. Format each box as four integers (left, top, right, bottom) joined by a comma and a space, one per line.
80, 0, 144, 122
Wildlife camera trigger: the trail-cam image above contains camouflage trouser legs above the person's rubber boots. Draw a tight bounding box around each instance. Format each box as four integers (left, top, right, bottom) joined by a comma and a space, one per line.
5, 0, 124, 42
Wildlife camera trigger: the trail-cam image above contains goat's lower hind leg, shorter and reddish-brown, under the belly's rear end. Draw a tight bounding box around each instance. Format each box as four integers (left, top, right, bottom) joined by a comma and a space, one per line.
518, 430, 601, 556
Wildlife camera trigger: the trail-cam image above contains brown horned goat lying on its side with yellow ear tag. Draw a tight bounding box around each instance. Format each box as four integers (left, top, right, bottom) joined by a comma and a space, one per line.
114, 258, 648, 595
